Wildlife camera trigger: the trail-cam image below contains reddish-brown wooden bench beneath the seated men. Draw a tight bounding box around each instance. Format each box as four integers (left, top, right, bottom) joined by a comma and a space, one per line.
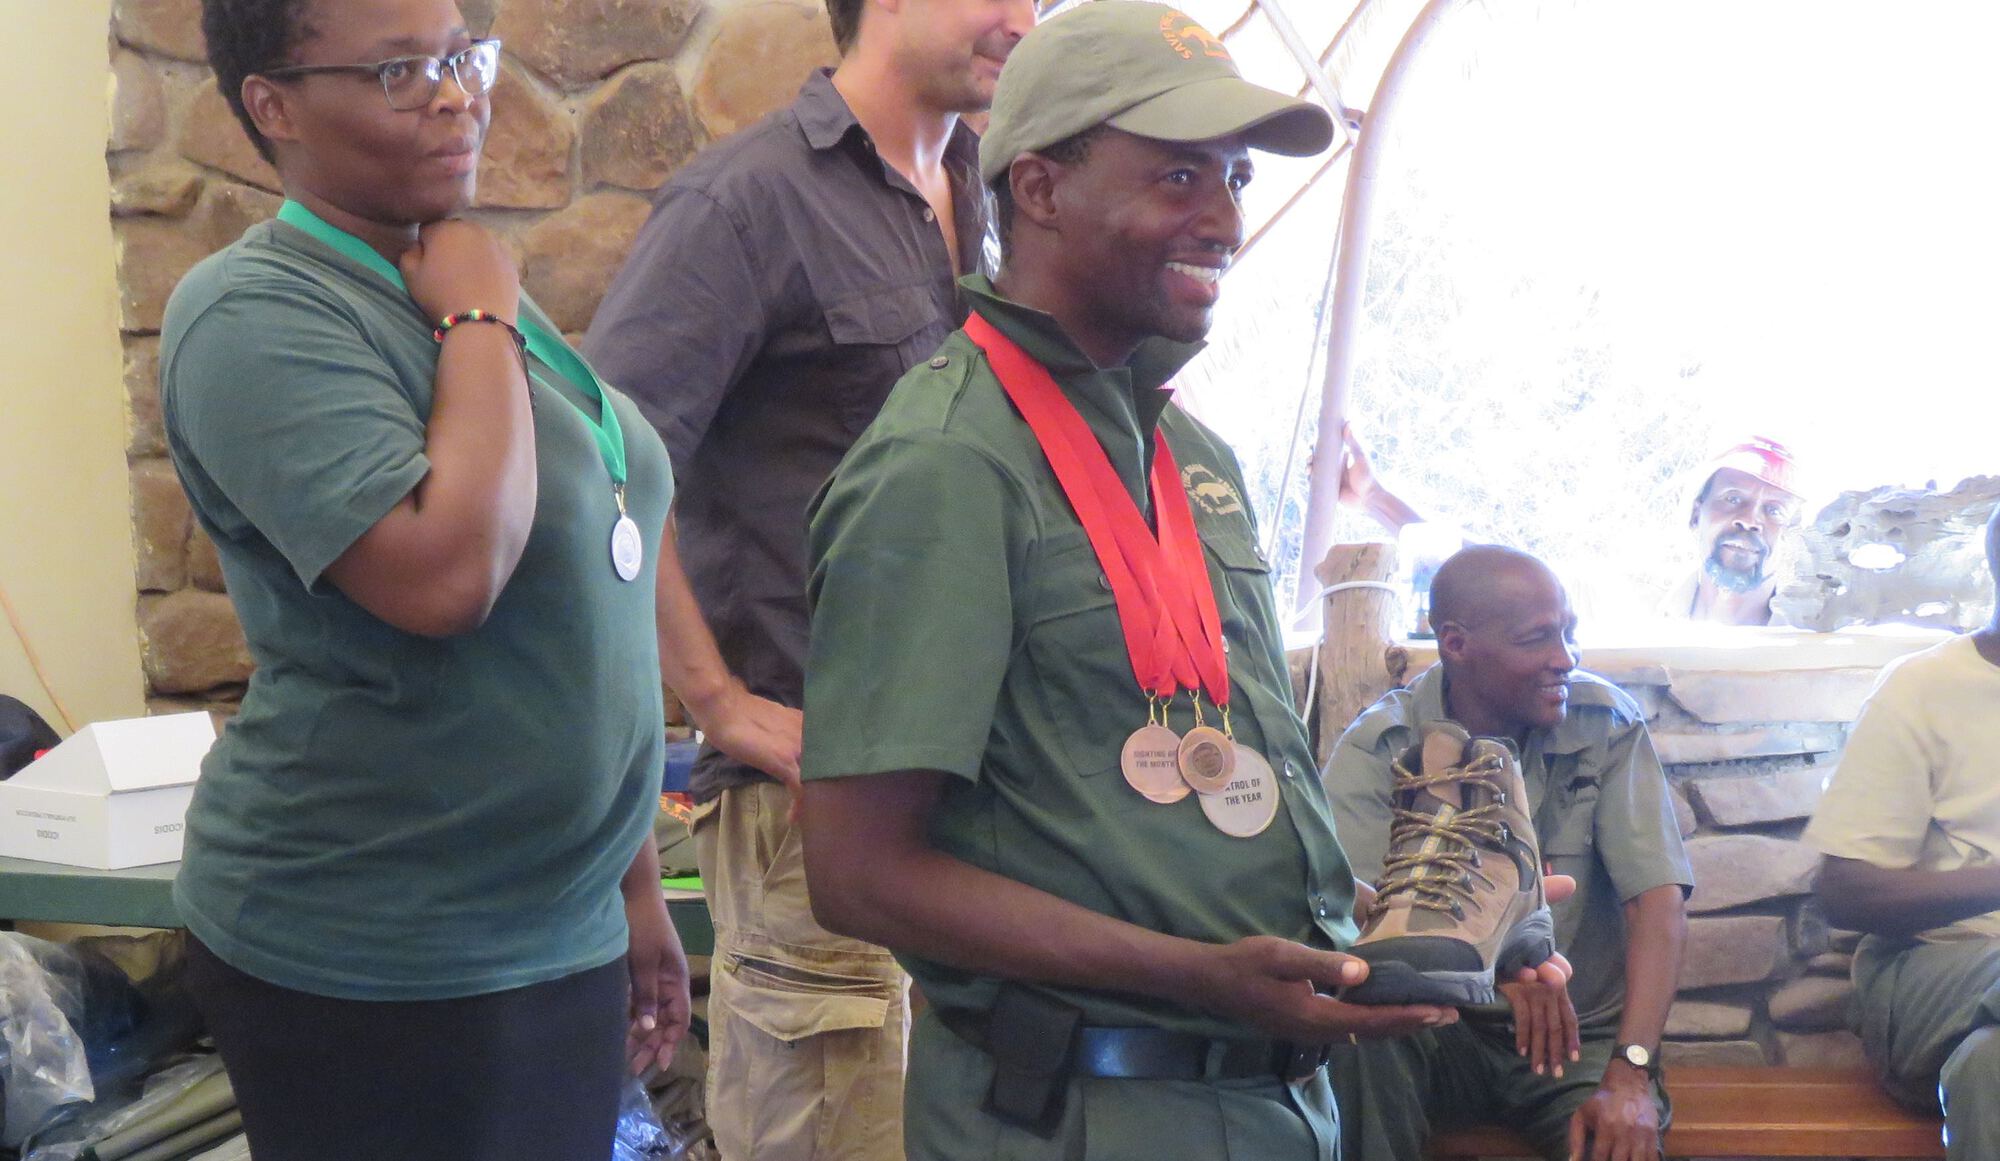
1430, 1067, 1944, 1161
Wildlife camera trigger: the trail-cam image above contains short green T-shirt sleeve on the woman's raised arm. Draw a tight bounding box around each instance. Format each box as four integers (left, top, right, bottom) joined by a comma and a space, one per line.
162, 286, 430, 587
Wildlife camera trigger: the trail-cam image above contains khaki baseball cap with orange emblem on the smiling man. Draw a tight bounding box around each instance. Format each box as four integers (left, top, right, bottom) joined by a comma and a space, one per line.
980, 0, 1334, 186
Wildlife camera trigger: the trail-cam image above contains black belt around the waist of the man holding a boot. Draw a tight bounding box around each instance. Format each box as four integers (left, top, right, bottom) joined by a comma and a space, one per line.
936, 1009, 1326, 1081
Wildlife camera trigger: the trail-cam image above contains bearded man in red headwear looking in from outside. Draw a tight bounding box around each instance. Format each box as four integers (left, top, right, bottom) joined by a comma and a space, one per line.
1660, 436, 1804, 625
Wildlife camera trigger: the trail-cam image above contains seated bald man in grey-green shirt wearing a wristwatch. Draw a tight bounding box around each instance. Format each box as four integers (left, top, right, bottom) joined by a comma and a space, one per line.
1326, 544, 1694, 1161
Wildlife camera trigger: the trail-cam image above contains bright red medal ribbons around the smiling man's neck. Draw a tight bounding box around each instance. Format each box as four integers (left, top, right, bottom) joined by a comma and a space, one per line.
966, 314, 1230, 707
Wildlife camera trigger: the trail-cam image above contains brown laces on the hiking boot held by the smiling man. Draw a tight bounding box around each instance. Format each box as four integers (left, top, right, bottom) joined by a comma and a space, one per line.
1370, 755, 1506, 919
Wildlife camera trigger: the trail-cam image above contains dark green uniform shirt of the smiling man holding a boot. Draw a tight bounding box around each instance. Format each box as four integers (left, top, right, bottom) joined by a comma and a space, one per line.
802, 276, 1354, 1037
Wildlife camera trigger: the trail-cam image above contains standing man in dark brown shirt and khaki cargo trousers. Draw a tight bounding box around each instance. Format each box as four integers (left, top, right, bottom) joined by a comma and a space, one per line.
584, 0, 1034, 1161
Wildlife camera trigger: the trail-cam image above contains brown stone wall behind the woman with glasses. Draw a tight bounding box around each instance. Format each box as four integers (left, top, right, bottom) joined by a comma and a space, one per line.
106, 0, 836, 711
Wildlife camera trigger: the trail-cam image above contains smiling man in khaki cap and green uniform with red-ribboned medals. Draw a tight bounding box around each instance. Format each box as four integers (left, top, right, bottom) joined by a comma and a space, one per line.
802, 0, 1576, 1161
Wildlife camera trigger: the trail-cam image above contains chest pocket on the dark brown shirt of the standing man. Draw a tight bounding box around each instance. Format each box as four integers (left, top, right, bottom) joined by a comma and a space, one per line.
820, 286, 952, 434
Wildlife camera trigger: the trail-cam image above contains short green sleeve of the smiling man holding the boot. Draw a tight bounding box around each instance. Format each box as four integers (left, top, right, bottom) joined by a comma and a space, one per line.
802, 434, 1020, 781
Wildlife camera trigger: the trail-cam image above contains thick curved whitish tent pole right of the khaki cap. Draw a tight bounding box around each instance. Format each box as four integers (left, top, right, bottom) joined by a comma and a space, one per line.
1258, 0, 1466, 625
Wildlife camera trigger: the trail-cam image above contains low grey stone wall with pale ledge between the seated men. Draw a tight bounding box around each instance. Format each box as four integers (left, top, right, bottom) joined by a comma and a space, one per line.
1368, 631, 1936, 1067
